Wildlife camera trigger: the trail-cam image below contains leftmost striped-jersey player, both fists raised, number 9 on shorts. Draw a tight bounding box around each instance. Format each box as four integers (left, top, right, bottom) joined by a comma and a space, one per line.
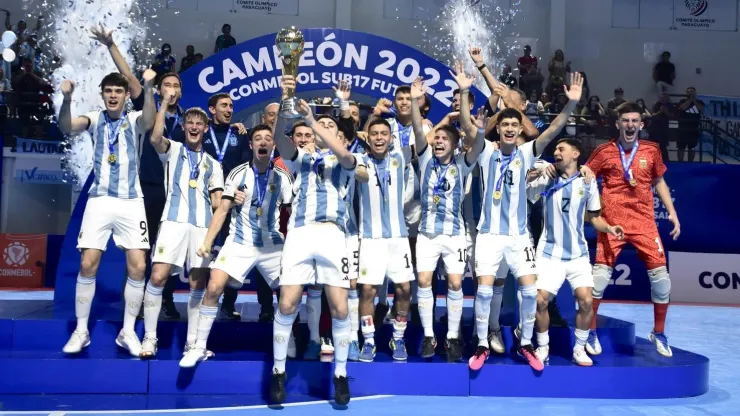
59, 70, 156, 356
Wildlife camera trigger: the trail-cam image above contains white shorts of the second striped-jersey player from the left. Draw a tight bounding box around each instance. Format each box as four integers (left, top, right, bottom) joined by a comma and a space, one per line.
152, 221, 211, 274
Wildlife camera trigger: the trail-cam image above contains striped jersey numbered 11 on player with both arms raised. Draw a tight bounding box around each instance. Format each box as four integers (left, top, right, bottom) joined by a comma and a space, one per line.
478, 140, 537, 236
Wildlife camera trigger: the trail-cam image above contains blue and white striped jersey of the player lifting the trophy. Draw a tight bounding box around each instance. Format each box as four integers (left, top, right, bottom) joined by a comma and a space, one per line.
283, 149, 362, 231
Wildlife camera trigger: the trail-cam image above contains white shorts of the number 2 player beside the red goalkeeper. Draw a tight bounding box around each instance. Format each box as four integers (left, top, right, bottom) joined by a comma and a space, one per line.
537, 256, 594, 295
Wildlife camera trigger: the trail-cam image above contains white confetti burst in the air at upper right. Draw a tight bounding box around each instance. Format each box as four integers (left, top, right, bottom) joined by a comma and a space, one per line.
416, 0, 521, 93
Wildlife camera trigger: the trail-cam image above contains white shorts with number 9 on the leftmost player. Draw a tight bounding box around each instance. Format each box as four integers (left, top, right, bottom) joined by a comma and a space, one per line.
77, 196, 151, 251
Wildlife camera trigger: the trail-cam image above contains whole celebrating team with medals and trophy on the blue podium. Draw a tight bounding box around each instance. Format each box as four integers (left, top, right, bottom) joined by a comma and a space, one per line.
59, 27, 680, 404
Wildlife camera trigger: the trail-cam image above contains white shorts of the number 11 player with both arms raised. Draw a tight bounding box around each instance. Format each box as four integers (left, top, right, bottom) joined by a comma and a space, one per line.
475, 234, 537, 279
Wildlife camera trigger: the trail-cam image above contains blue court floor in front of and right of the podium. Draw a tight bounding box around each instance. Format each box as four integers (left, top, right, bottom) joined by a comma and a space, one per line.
0, 294, 740, 416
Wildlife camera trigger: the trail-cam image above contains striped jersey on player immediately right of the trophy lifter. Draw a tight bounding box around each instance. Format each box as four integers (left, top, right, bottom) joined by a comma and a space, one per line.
357, 150, 408, 238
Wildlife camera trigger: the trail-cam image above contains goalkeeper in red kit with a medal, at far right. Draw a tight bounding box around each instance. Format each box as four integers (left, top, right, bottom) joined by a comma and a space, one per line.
586, 103, 681, 357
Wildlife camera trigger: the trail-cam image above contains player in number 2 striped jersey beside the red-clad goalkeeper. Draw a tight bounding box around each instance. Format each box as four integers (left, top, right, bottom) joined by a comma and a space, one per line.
527, 139, 624, 366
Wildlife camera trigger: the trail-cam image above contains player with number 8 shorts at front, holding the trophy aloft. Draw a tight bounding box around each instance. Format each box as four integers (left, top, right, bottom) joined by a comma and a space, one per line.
270, 76, 359, 405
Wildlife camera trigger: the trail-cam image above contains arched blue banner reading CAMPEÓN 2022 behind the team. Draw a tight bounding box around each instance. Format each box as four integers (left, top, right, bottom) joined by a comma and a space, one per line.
180, 29, 486, 120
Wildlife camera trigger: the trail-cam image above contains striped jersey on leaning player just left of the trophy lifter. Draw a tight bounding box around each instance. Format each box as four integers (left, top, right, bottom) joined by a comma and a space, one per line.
223, 162, 293, 247
